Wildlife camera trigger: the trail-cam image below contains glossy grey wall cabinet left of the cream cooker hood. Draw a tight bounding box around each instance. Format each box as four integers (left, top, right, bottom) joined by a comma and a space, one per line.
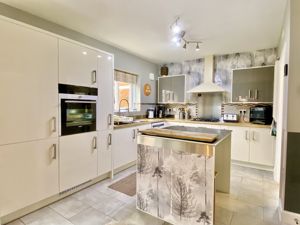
158, 75, 196, 103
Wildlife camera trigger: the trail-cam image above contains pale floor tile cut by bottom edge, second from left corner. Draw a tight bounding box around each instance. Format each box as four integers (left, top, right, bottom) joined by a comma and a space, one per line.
70, 208, 113, 225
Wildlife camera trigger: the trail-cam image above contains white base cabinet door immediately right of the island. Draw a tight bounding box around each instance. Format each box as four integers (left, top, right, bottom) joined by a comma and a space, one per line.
226, 126, 250, 162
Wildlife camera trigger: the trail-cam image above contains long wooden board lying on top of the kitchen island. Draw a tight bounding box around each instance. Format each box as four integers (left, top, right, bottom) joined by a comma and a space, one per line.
140, 129, 218, 143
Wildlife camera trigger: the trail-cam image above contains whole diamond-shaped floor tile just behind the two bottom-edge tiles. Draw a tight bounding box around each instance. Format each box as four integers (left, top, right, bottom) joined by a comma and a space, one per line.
49, 196, 89, 219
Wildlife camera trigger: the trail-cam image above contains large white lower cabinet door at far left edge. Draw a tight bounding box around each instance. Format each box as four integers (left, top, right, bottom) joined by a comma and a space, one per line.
0, 138, 59, 217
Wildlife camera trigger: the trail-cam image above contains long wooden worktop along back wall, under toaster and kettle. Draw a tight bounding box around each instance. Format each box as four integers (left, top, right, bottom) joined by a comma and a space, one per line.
114, 118, 271, 129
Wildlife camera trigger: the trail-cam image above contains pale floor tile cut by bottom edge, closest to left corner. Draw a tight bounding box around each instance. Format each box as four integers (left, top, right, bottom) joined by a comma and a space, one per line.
21, 207, 72, 225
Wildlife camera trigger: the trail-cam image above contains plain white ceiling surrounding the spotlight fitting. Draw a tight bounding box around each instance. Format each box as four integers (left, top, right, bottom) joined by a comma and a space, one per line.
1, 0, 286, 63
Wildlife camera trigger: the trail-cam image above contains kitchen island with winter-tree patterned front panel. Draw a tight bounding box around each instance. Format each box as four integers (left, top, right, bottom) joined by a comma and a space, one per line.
137, 126, 231, 225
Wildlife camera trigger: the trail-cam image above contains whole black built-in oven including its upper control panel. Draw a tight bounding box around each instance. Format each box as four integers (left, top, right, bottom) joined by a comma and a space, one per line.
59, 84, 97, 136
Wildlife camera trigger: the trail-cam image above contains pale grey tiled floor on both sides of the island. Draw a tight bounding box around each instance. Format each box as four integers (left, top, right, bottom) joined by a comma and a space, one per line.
9, 163, 279, 225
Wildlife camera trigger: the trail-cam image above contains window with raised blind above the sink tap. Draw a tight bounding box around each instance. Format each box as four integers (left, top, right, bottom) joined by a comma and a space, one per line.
114, 70, 139, 112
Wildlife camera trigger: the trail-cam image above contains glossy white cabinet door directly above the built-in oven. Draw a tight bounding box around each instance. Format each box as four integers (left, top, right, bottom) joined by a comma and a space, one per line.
59, 40, 98, 87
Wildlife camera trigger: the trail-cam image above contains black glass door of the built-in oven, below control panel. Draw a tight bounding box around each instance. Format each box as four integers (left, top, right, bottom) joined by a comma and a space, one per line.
60, 99, 97, 136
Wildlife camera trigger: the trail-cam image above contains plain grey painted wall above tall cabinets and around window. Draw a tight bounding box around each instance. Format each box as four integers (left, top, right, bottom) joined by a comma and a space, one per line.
0, 3, 159, 112
